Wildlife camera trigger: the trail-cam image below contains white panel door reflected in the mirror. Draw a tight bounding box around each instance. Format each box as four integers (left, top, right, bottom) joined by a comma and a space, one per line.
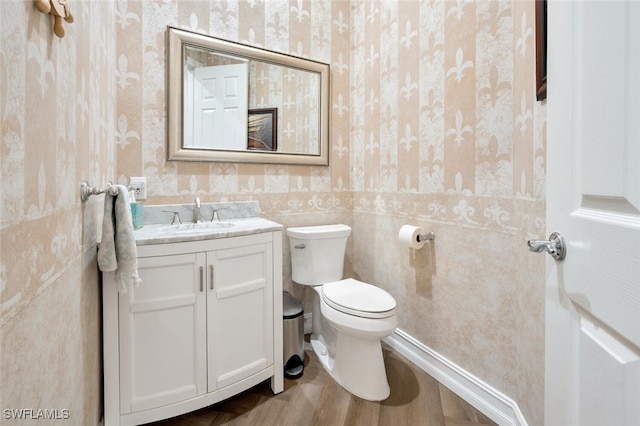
193, 63, 249, 150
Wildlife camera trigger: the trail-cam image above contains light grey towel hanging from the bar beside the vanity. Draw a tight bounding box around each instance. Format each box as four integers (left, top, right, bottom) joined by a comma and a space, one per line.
98, 185, 142, 293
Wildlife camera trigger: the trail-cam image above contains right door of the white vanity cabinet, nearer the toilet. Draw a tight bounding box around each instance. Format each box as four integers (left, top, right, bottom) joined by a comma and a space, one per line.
207, 243, 273, 391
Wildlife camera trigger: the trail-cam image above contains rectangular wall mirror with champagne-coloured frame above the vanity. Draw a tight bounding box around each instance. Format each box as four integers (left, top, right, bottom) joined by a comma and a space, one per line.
167, 27, 330, 165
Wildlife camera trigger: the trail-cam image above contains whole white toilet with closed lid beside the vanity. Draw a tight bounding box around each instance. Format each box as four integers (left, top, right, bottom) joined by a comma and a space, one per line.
287, 225, 398, 401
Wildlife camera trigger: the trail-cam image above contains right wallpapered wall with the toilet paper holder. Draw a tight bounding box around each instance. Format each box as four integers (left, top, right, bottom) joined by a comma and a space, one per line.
350, 1, 546, 425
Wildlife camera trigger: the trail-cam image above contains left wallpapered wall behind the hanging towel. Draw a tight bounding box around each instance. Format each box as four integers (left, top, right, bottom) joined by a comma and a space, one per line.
0, 1, 115, 425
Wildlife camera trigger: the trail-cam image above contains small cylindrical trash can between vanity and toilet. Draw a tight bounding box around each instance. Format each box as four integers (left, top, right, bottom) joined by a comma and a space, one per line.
282, 291, 304, 379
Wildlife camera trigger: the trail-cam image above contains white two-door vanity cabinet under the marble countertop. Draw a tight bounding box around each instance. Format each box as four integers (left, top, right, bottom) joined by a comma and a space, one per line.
103, 231, 284, 426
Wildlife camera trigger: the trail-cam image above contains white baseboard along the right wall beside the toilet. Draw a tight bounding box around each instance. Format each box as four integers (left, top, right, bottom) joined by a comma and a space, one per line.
384, 329, 527, 426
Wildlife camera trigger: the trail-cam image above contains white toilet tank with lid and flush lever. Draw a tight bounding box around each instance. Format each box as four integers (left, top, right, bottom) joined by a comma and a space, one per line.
287, 225, 351, 285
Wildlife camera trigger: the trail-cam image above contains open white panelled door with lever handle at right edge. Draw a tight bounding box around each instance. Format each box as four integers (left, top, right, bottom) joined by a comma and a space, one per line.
545, 0, 640, 426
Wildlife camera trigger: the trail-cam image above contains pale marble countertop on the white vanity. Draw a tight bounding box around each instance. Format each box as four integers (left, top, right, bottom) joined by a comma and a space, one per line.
133, 217, 283, 246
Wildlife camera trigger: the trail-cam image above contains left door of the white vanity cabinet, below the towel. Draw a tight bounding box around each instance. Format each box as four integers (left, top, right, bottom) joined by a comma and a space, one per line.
119, 253, 207, 414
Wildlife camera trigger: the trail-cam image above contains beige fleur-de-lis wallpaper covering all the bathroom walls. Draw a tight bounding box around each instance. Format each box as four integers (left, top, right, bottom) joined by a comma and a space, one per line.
0, 0, 546, 425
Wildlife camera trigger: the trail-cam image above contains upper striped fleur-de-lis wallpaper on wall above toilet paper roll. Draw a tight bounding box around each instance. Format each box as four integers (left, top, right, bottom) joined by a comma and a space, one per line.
350, 1, 544, 220
